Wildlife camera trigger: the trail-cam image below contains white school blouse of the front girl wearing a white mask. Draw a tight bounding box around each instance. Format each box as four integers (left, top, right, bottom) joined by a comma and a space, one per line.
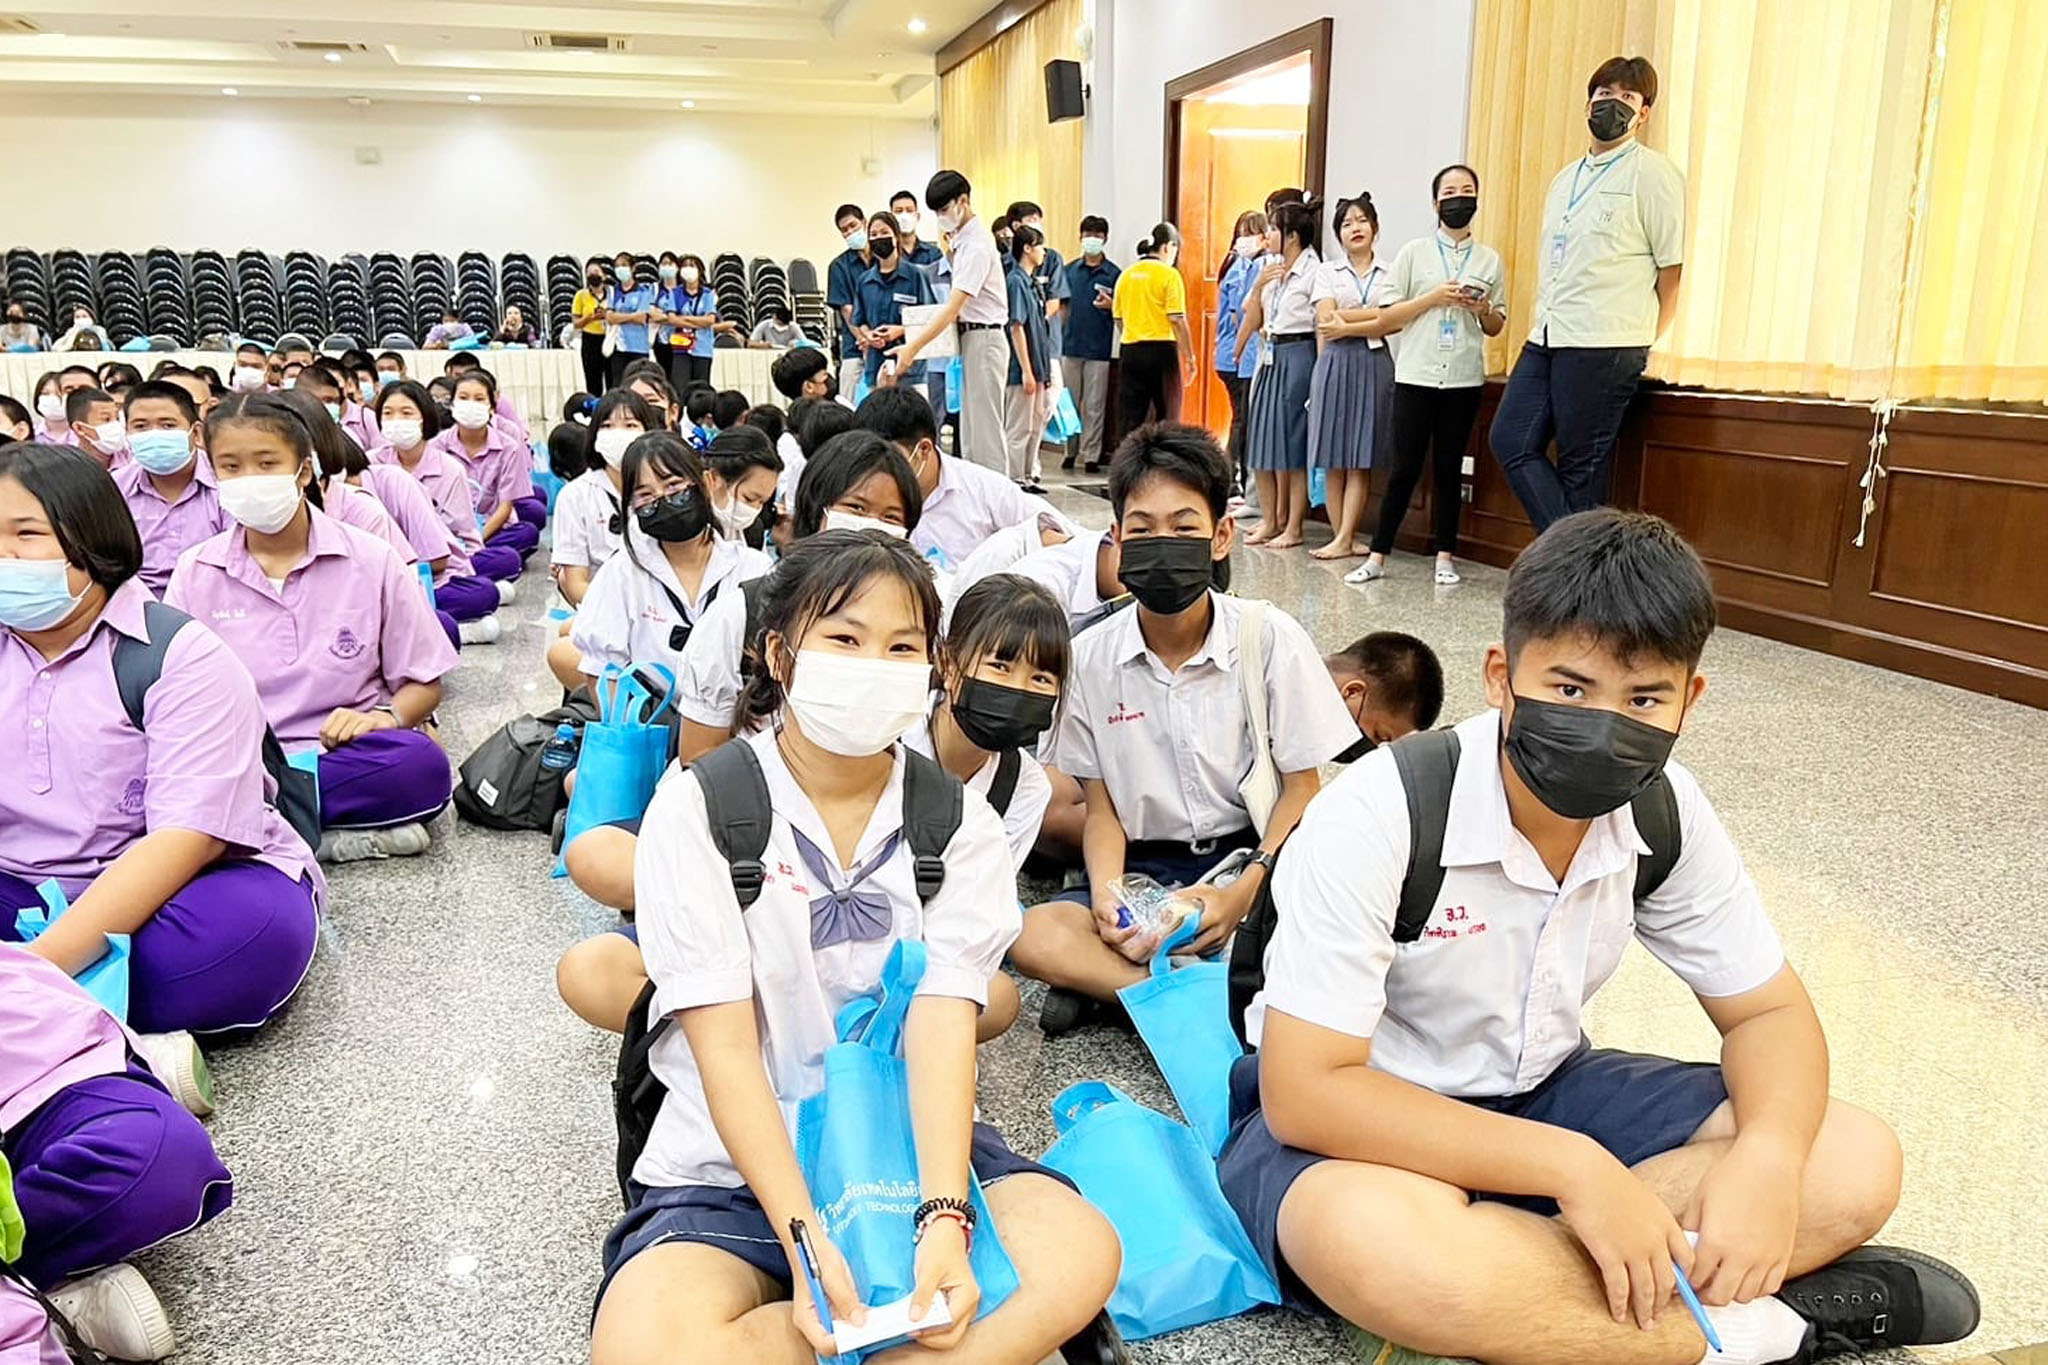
633, 729, 1024, 1187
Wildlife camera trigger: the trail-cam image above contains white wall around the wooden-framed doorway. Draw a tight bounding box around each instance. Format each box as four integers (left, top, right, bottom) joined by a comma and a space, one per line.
1085, 0, 1485, 254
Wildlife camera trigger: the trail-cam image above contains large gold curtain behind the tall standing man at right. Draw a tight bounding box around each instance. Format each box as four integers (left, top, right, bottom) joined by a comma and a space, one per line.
1470, 0, 2048, 401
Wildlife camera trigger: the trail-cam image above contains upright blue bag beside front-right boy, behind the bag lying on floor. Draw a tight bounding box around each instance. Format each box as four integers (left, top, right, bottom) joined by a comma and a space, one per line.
1116, 917, 1245, 1156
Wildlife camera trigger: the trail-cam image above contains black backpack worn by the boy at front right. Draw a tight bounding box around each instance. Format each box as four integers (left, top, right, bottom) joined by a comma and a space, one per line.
1231, 731, 1679, 1050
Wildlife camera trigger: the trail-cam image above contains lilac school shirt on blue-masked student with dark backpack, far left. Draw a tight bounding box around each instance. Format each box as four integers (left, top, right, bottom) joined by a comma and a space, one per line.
0, 573, 323, 902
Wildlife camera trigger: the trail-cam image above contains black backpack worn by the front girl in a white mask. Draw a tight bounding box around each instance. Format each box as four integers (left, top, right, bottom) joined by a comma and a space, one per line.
612, 740, 963, 1207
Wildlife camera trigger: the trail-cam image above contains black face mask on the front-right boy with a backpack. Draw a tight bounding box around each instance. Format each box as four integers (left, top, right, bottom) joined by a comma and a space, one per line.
1505, 696, 1677, 821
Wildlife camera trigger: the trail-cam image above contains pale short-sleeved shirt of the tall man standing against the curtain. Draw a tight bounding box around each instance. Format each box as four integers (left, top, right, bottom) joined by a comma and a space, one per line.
1530, 139, 1686, 346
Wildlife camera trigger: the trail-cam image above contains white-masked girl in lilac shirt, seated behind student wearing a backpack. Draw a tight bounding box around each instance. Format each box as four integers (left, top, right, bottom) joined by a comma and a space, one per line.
164, 395, 457, 862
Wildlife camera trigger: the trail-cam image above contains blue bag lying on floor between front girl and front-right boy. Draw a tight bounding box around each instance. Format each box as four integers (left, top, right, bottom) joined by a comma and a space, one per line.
1038, 1081, 1280, 1340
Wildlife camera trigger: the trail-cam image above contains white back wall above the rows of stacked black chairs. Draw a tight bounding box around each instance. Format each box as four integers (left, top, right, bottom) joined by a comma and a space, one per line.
0, 96, 938, 268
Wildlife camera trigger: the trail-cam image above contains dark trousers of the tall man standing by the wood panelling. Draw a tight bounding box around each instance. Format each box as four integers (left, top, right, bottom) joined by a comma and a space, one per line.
1489, 342, 1651, 532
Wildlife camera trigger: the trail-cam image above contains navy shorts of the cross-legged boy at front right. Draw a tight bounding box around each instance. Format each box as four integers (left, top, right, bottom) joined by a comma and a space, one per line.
1217, 1040, 1729, 1316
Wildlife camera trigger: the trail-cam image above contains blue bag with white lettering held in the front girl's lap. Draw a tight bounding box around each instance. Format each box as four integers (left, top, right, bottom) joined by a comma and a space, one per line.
797, 939, 1018, 1365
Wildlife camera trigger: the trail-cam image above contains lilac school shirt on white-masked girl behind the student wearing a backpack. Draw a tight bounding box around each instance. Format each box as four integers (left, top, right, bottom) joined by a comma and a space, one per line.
164, 512, 455, 749
